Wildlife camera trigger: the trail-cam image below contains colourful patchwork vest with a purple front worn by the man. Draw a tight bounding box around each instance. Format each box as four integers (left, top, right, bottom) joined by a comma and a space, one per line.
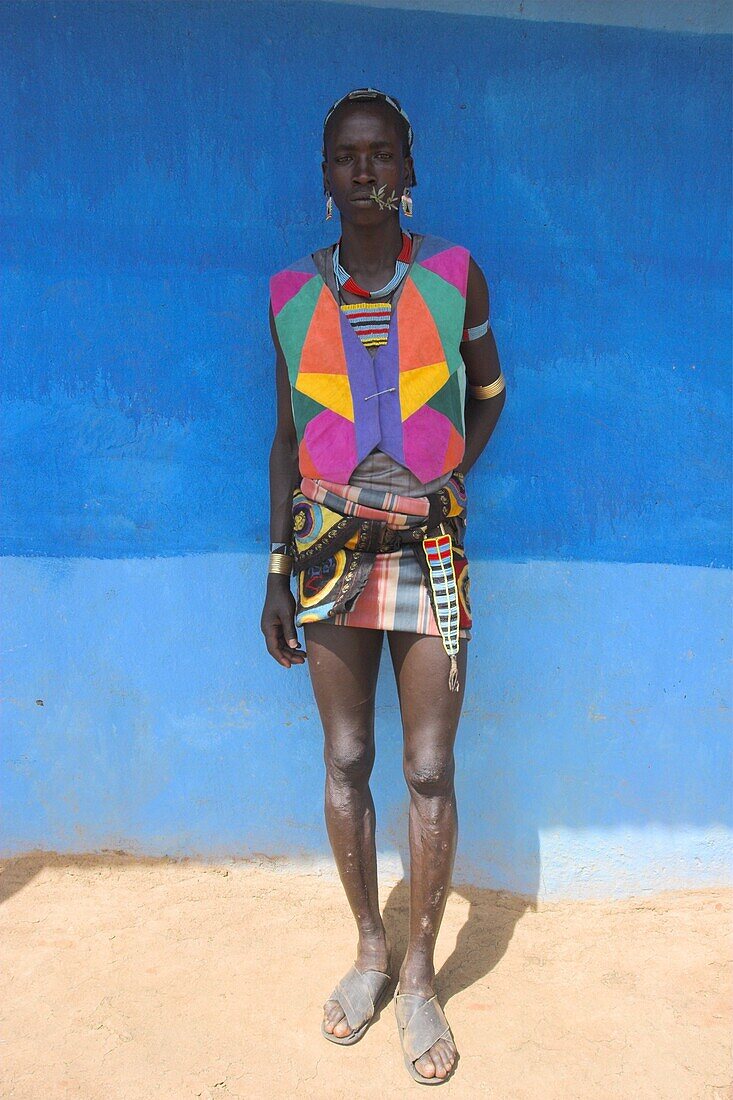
270, 233, 469, 483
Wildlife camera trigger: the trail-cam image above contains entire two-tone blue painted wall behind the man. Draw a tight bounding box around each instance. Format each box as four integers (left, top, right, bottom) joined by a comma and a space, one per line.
0, 2, 733, 895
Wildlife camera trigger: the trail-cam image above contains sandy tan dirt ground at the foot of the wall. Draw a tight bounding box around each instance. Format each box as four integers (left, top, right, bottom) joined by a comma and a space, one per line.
0, 854, 733, 1100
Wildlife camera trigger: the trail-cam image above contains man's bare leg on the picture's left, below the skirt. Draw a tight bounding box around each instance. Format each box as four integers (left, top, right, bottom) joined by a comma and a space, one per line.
305, 623, 389, 1037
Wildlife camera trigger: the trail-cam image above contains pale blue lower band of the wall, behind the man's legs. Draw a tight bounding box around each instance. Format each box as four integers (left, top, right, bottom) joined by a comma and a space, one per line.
0, 553, 733, 899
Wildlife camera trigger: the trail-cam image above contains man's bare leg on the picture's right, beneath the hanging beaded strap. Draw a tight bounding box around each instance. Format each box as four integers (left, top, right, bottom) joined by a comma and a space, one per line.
389, 633, 467, 1077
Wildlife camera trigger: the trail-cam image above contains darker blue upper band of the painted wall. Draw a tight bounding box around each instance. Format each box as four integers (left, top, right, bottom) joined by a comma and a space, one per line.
0, 2, 731, 565
